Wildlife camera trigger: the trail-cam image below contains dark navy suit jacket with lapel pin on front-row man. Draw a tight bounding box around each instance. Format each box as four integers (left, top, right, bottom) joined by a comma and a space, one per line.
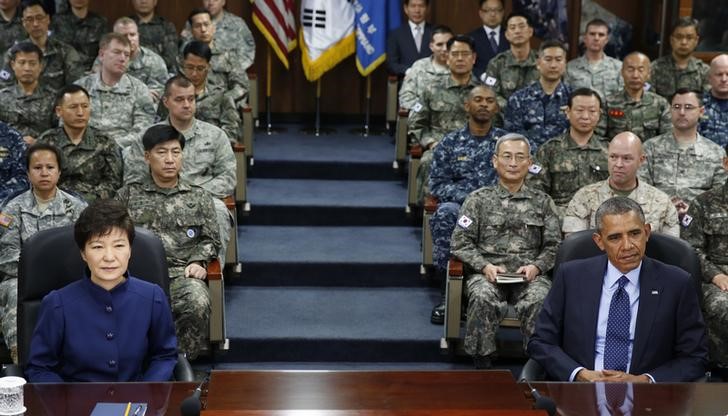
528, 255, 708, 382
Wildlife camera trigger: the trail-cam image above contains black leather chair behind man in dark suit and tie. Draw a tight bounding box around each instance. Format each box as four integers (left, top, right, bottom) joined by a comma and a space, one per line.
518, 230, 703, 381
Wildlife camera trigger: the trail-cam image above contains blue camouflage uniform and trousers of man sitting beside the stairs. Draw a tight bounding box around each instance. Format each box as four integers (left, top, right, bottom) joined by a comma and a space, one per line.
430, 126, 506, 270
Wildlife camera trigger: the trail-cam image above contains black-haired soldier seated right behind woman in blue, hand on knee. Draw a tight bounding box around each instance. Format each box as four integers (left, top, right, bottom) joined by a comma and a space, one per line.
116, 124, 220, 359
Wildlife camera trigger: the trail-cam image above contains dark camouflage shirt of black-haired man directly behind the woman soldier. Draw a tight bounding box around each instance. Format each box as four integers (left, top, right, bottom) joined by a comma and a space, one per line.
38, 127, 124, 202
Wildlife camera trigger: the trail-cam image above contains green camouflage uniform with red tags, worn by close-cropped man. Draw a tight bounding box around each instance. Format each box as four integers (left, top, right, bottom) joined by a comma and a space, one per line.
595, 90, 672, 142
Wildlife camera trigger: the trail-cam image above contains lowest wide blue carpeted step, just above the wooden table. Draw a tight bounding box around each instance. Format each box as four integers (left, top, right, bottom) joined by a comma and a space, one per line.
225, 287, 443, 362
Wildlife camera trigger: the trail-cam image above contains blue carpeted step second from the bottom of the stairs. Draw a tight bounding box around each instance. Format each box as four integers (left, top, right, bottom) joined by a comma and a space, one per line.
236, 226, 423, 287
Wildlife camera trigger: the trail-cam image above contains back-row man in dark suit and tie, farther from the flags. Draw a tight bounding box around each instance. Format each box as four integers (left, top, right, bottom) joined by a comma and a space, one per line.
470, 0, 511, 77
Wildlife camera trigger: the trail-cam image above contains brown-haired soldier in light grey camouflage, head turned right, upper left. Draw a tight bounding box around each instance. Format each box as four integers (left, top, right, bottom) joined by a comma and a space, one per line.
76, 33, 155, 148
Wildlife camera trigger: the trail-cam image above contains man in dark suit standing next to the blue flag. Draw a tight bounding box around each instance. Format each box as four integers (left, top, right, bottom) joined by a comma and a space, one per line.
387, 0, 432, 78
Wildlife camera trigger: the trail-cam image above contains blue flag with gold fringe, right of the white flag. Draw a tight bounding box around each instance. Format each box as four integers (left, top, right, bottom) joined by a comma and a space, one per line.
351, 0, 402, 76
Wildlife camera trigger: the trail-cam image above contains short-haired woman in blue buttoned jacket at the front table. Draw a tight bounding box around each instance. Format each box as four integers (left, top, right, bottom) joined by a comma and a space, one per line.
25, 200, 177, 383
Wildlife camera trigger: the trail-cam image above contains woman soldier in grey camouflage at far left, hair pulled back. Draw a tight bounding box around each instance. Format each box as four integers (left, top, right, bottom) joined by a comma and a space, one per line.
0, 143, 86, 364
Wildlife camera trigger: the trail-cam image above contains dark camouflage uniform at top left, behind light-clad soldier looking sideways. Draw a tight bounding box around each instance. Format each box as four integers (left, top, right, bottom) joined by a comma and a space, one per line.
50, 11, 109, 70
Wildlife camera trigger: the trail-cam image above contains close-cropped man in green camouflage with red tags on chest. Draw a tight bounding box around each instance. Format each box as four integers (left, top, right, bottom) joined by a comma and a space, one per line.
596, 52, 671, 141
